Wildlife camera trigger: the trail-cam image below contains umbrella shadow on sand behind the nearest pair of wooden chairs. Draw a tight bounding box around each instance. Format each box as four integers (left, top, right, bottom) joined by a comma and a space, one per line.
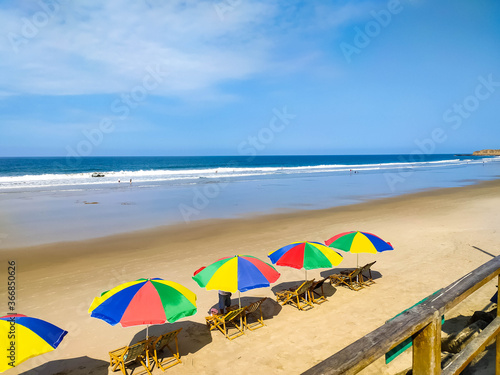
129, 321, 212, 358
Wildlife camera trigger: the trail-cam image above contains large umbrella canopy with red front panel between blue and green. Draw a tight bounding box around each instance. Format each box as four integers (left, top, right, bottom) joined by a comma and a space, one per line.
89, 278, 197, 327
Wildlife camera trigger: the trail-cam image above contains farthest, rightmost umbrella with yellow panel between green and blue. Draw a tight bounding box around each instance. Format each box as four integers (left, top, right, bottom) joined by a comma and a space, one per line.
325, 231, 394, 266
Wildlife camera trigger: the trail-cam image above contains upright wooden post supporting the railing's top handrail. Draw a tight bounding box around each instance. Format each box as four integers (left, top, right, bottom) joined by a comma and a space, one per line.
413, 311, 441, 375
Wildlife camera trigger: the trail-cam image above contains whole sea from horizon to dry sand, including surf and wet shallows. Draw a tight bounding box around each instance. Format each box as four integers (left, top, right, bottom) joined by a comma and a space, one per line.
0, 154, 500, 248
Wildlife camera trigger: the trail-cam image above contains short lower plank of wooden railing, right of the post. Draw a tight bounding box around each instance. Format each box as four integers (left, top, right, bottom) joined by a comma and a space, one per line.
442, 317, 500, 375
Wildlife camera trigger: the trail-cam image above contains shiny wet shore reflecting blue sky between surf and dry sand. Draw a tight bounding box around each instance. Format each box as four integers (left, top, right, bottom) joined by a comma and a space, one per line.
0, 156, 500, 249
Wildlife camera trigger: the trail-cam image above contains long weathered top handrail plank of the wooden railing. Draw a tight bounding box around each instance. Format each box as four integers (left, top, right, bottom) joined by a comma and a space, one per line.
303, 256, 500, 375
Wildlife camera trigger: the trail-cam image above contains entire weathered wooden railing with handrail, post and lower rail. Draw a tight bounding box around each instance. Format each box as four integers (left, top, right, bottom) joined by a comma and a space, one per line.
303, 256, 500, 375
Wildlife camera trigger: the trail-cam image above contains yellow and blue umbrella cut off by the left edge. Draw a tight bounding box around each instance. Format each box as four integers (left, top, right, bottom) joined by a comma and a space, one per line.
0, 314, 68, 372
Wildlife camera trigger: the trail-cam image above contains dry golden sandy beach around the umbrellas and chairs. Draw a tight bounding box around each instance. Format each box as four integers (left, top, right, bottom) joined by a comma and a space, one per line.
1, 180, 500, 375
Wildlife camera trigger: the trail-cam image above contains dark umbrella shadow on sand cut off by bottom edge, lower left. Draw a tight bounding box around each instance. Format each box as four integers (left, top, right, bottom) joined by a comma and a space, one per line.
23, 356, 109, 375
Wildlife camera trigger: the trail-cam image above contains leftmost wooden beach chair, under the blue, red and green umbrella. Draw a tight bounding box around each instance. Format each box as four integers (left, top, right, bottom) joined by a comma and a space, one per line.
109, 337, 156, 375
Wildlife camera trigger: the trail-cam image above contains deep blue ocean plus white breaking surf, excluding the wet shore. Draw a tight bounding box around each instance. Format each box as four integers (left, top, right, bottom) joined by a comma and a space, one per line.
0, 154, 498, 192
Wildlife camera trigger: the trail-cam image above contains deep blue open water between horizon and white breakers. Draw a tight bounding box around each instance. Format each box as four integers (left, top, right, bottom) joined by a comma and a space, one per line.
0, 154, 483, 177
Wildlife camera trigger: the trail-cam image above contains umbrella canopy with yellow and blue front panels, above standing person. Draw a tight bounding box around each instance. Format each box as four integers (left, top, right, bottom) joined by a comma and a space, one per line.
193, 255, 280, 293
